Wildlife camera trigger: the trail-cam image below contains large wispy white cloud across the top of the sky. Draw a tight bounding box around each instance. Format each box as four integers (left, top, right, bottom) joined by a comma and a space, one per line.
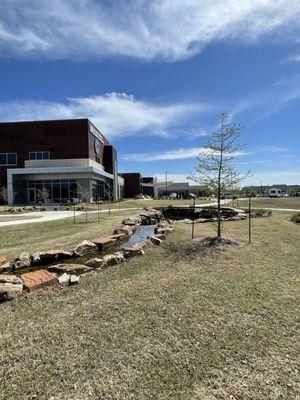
0, 0, 300, 61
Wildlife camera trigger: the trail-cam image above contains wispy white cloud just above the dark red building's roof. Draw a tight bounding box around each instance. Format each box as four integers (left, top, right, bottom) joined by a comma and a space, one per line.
0, 93, 209, 138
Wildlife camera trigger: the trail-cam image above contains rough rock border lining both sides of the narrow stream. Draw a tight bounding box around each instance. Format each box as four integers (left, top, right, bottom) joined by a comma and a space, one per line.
0, 209, 173, 300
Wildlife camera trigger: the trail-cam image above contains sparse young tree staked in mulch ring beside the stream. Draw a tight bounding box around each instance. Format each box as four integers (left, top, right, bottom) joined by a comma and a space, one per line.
188, 113, 249, 239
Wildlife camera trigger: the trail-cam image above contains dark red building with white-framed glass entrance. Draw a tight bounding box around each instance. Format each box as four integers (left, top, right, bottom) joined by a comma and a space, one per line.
0, 119, 123, 204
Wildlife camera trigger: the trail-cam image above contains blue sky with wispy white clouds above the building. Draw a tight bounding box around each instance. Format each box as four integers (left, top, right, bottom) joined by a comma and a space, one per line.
0, 0, 300, 184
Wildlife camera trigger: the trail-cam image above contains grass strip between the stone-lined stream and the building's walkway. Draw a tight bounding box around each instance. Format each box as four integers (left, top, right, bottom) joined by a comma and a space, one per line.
0, 210, 140, 257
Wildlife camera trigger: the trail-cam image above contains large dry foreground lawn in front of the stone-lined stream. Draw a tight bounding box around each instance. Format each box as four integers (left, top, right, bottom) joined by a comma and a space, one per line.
0, 212, 300, 400
